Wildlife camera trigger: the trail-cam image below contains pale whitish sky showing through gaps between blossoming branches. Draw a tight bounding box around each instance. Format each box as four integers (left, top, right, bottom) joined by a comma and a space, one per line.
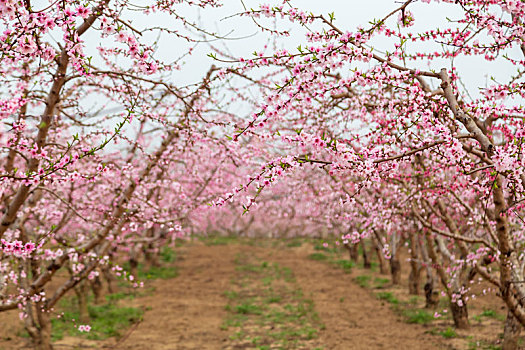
20, 0, 521, 126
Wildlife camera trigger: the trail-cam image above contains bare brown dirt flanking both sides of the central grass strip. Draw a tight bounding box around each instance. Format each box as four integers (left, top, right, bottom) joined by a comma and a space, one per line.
0, 243, 508, 350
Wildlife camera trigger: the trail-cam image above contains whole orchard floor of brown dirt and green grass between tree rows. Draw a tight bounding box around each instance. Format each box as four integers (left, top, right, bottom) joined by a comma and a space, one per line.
0, 239, 516, 350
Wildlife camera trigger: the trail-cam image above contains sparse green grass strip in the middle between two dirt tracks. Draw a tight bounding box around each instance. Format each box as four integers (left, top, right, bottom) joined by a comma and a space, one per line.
221, 254, 324, 349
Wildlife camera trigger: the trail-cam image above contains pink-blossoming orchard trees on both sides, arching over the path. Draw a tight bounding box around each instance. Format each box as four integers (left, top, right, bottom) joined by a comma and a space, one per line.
0, 0, 525, 349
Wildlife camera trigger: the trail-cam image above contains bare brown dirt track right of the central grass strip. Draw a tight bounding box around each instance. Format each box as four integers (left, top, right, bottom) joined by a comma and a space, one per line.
270, 249, 445, 350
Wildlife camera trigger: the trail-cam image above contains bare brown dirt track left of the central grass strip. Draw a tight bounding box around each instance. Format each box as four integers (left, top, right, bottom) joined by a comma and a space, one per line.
115, 245, 242, 350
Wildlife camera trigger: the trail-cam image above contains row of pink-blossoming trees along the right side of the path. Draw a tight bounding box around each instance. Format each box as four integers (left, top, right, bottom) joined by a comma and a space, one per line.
212, 1, 525, 348
